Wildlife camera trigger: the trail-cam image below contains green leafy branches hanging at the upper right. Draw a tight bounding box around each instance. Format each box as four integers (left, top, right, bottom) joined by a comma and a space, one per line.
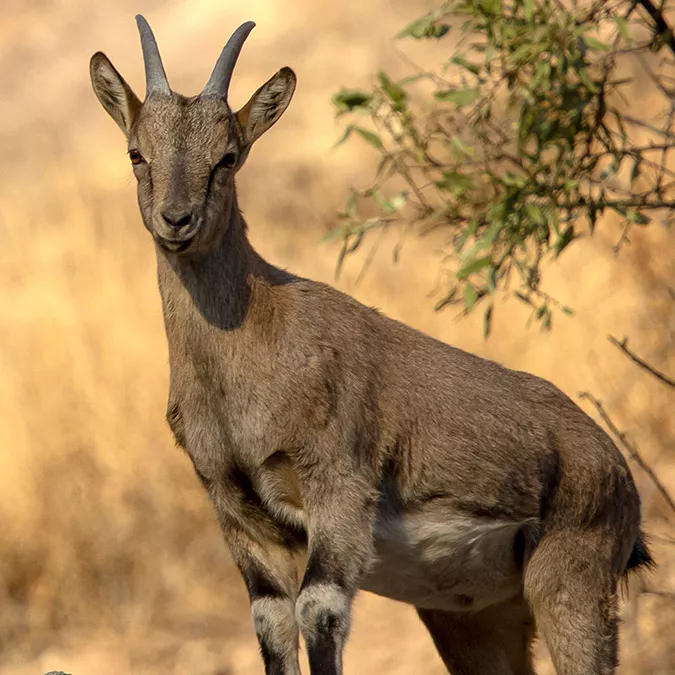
329, 0, 675, 335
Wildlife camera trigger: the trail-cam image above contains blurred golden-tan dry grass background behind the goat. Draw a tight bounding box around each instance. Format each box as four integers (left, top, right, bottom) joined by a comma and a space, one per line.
0, 0, 675, 675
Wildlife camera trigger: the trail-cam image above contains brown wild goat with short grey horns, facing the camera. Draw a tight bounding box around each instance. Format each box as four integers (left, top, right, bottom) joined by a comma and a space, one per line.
91, 16, 651, 675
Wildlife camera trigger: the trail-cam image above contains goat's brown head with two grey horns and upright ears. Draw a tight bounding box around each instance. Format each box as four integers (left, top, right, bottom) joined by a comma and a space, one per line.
90, 16, 296, 253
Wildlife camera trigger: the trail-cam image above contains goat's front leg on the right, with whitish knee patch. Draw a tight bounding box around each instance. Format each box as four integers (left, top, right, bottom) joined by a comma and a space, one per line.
295, 465, 377, 675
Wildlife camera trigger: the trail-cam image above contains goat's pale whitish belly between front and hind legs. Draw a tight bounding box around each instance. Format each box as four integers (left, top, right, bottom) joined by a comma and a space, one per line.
361, 513, 529, 612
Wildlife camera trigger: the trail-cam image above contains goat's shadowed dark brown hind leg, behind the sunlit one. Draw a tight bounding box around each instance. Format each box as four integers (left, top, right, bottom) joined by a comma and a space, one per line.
417, 598, 534, 675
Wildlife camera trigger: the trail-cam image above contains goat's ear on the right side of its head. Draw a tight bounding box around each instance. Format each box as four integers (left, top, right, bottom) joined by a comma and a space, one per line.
237, 68, 297, 145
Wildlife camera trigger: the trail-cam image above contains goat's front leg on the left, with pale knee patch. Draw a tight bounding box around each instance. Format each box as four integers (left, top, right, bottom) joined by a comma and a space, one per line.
215, 493, 300, 675
